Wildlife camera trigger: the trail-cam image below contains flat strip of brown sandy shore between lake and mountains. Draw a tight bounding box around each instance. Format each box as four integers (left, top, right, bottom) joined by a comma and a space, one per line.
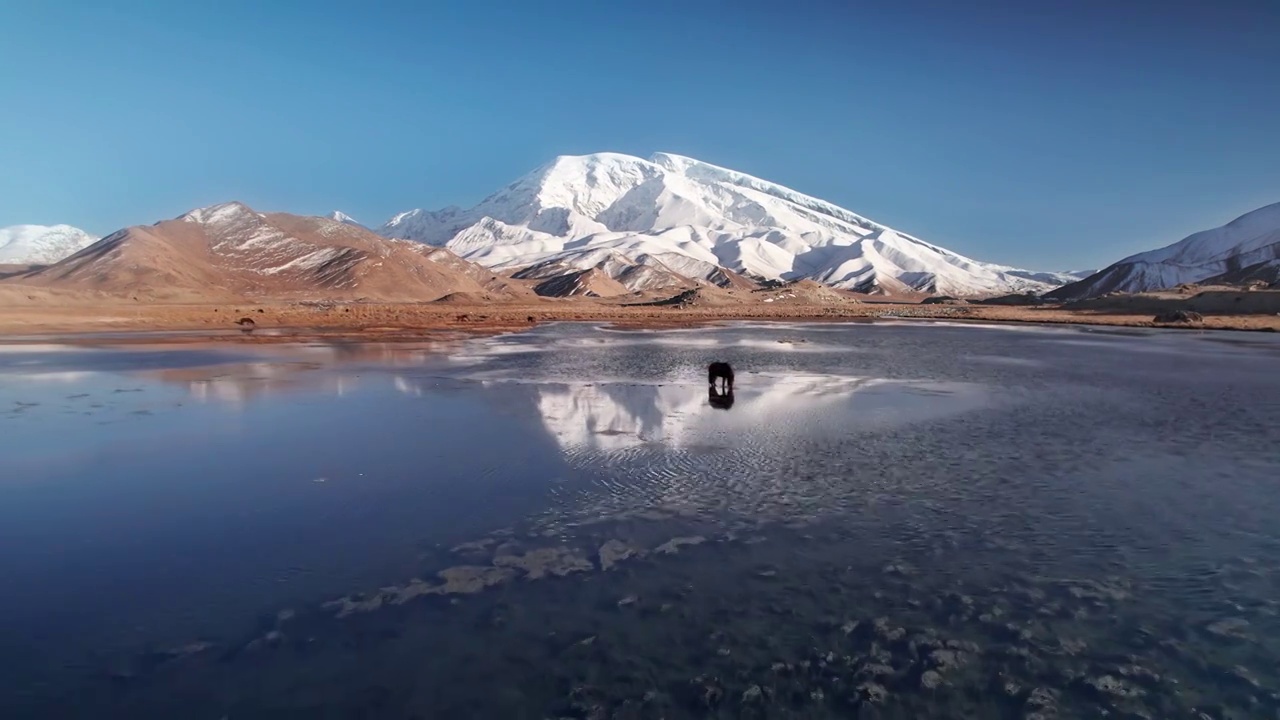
0, 301, 1280, 342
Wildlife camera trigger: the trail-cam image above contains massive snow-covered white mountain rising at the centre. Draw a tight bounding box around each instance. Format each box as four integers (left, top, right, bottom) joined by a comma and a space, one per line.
378, 152, 1068, 295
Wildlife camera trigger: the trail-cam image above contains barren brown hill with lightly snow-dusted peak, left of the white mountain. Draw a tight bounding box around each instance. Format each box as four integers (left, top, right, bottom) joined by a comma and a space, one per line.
3, 202, 531, 302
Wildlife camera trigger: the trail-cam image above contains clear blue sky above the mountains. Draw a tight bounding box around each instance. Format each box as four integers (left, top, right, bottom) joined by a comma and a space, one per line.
0, 0, 1280, 269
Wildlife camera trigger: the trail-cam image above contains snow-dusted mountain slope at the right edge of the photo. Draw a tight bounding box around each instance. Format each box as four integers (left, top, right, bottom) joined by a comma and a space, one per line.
1050, 202, 1280, 300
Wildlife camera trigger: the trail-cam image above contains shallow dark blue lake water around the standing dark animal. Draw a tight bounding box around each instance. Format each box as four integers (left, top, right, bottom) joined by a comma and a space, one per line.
0, 323, 1280, 720
